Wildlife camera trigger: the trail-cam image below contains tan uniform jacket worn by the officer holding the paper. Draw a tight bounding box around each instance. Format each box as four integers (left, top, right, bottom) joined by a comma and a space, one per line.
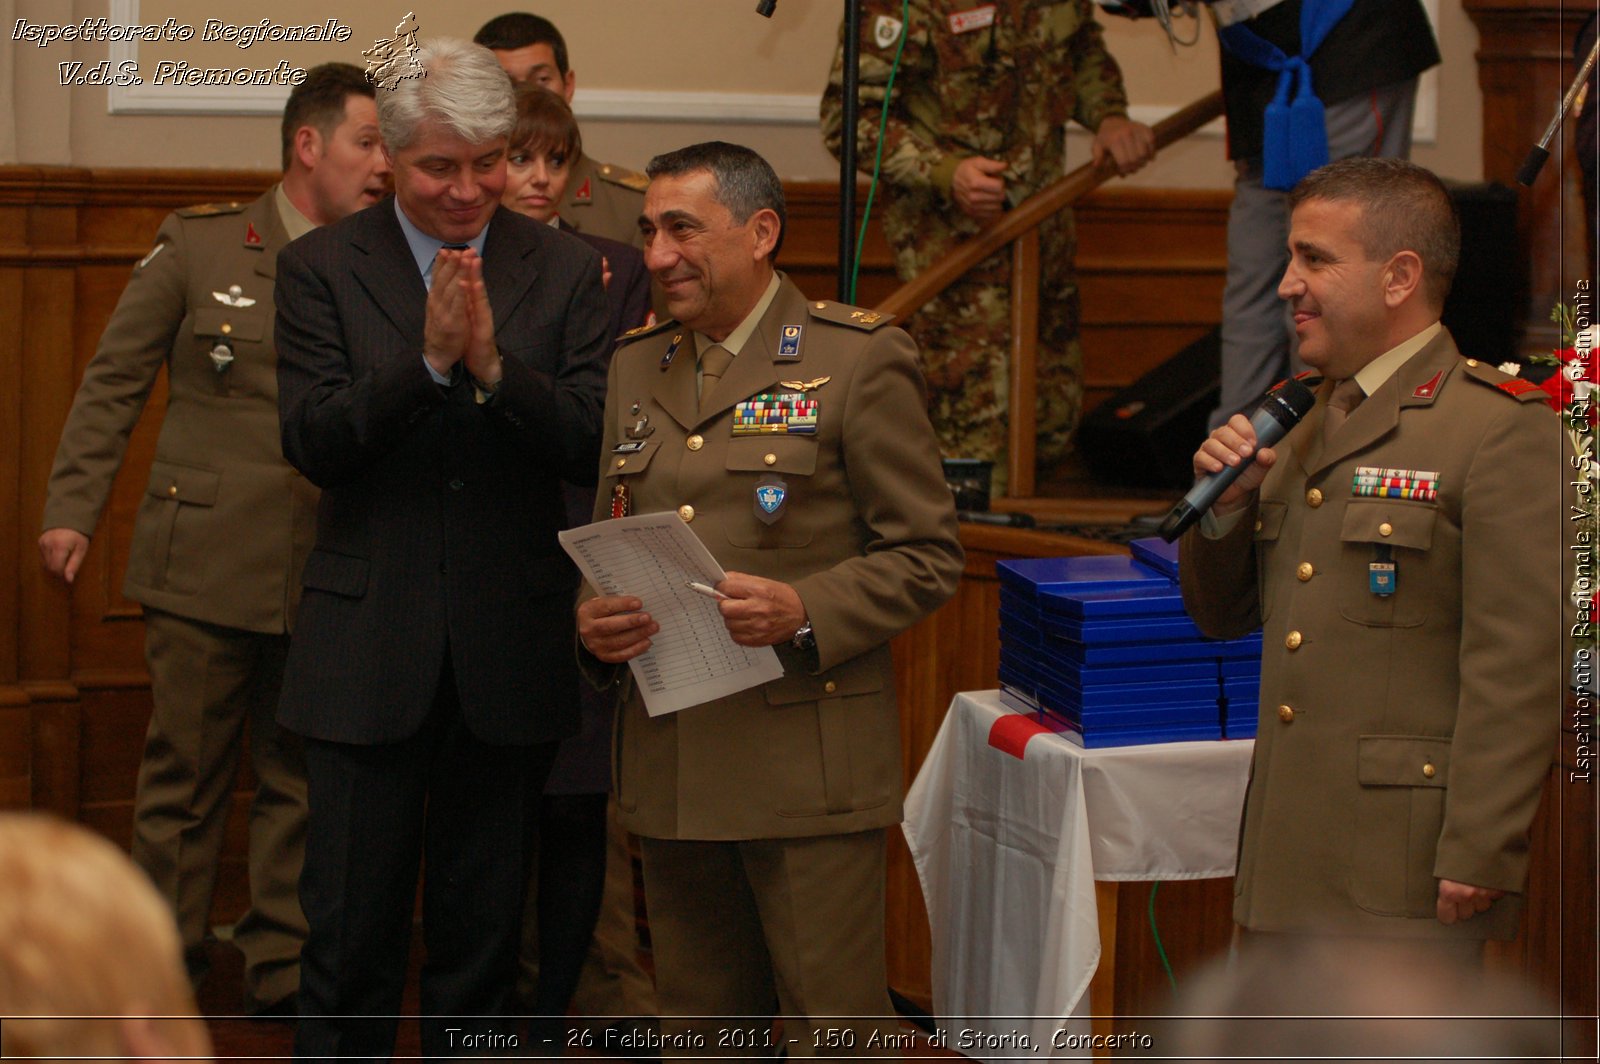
589, 280, 962, 840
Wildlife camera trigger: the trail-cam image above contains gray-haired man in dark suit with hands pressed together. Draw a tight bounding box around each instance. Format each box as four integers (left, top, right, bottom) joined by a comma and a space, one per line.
278, 40, 608, 1056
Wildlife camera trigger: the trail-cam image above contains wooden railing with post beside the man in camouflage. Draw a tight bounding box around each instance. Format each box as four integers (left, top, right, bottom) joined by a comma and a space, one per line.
874, 91, 1222, 499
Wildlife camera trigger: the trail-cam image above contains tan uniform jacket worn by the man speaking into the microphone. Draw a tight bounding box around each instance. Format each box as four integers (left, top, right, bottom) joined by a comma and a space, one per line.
1181, 331, 1571, 939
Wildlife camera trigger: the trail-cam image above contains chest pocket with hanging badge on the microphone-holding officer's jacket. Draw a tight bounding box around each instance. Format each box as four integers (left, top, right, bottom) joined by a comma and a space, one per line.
1338, 499, 1438, 627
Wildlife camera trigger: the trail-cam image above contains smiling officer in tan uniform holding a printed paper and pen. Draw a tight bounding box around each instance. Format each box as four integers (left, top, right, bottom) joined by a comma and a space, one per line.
578, 142, 962, 1056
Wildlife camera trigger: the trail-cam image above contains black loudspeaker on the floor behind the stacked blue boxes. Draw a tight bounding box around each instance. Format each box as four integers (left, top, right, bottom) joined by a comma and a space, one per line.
1078, 328, 1222, 490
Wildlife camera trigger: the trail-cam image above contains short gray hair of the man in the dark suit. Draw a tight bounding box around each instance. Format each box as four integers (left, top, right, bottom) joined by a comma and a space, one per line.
378, 37, 517, 152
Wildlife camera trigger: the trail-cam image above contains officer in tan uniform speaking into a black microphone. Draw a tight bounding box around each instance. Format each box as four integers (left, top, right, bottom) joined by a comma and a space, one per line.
1181, 157, 1573, 958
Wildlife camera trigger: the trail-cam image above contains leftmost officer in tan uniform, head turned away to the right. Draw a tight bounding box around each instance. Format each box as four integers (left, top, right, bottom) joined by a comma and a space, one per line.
38, 64, 389, 1011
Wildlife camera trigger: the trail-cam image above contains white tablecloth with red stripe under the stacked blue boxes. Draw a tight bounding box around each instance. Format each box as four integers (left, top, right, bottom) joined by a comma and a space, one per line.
902, 691, 1254, 1059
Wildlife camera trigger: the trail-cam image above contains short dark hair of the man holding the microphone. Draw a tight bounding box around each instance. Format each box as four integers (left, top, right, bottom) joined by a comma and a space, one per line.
1290, 157, 1461, 307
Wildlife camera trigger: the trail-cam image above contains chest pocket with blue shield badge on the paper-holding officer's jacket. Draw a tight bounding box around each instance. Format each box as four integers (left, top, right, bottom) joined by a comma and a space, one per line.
723, 435, 818, 550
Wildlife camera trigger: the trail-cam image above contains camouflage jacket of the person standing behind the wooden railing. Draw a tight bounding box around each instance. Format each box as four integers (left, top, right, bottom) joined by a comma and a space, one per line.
822, 0, 1128, 205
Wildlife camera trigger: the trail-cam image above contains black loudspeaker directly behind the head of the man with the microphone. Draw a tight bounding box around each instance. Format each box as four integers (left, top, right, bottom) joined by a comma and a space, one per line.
1443, 182, 1528, 366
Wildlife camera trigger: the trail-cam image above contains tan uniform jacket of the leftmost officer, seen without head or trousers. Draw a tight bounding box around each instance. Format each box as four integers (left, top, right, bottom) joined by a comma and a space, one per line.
43, 190, 317, 632
